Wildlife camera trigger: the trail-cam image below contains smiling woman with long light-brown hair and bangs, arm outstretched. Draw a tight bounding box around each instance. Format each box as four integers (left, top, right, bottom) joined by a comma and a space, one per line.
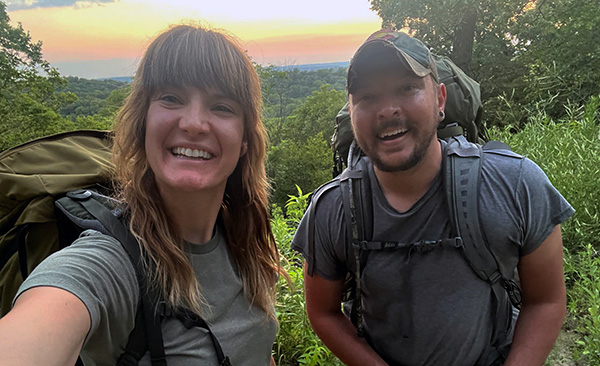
0, 26, 285, 366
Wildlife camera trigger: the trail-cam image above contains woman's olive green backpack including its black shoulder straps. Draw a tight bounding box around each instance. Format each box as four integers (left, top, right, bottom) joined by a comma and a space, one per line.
0, 130, 230, 366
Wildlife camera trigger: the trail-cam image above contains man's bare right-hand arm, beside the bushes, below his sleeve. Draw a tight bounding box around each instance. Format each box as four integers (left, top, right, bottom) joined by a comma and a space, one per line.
504, 225, 566, 366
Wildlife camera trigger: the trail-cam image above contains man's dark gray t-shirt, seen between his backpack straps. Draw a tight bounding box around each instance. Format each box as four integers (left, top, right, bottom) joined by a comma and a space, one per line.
292, 144, 574, 366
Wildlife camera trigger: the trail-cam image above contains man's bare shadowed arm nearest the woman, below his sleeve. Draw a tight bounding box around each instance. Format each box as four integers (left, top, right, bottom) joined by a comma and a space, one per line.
304, 264, 387, 366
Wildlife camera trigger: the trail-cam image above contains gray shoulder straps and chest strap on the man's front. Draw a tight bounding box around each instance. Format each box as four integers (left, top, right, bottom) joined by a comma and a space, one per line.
306, 135, 521, 351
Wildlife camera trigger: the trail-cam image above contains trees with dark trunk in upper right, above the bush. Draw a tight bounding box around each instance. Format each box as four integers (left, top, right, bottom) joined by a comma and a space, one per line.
371, 0, 600, 132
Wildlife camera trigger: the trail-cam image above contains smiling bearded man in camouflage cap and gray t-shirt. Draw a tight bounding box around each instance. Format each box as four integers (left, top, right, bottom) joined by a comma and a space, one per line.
292, 31, 574, 366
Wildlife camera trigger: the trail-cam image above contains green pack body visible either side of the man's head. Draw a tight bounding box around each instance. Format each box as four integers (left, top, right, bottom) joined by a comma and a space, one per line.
331, 54, 489, 177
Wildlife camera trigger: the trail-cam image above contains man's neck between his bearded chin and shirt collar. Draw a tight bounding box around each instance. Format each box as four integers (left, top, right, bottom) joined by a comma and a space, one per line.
373, 140, 442, 212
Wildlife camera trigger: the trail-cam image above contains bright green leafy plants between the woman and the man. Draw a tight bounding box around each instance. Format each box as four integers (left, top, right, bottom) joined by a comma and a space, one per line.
271, 192, 342, 366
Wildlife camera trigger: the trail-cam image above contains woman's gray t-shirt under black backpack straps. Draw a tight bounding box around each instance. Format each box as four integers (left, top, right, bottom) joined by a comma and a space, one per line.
17, 230, 276, 366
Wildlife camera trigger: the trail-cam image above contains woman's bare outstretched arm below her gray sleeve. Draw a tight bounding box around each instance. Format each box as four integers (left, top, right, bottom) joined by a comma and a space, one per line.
0, 287, 90, 366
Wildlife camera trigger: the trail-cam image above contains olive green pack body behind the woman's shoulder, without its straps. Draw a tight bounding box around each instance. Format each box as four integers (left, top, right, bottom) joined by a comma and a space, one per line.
0, 131, 111, 316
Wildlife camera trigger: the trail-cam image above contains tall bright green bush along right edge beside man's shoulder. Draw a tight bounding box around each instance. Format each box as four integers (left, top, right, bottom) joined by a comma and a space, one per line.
490, 96, 600, 366
